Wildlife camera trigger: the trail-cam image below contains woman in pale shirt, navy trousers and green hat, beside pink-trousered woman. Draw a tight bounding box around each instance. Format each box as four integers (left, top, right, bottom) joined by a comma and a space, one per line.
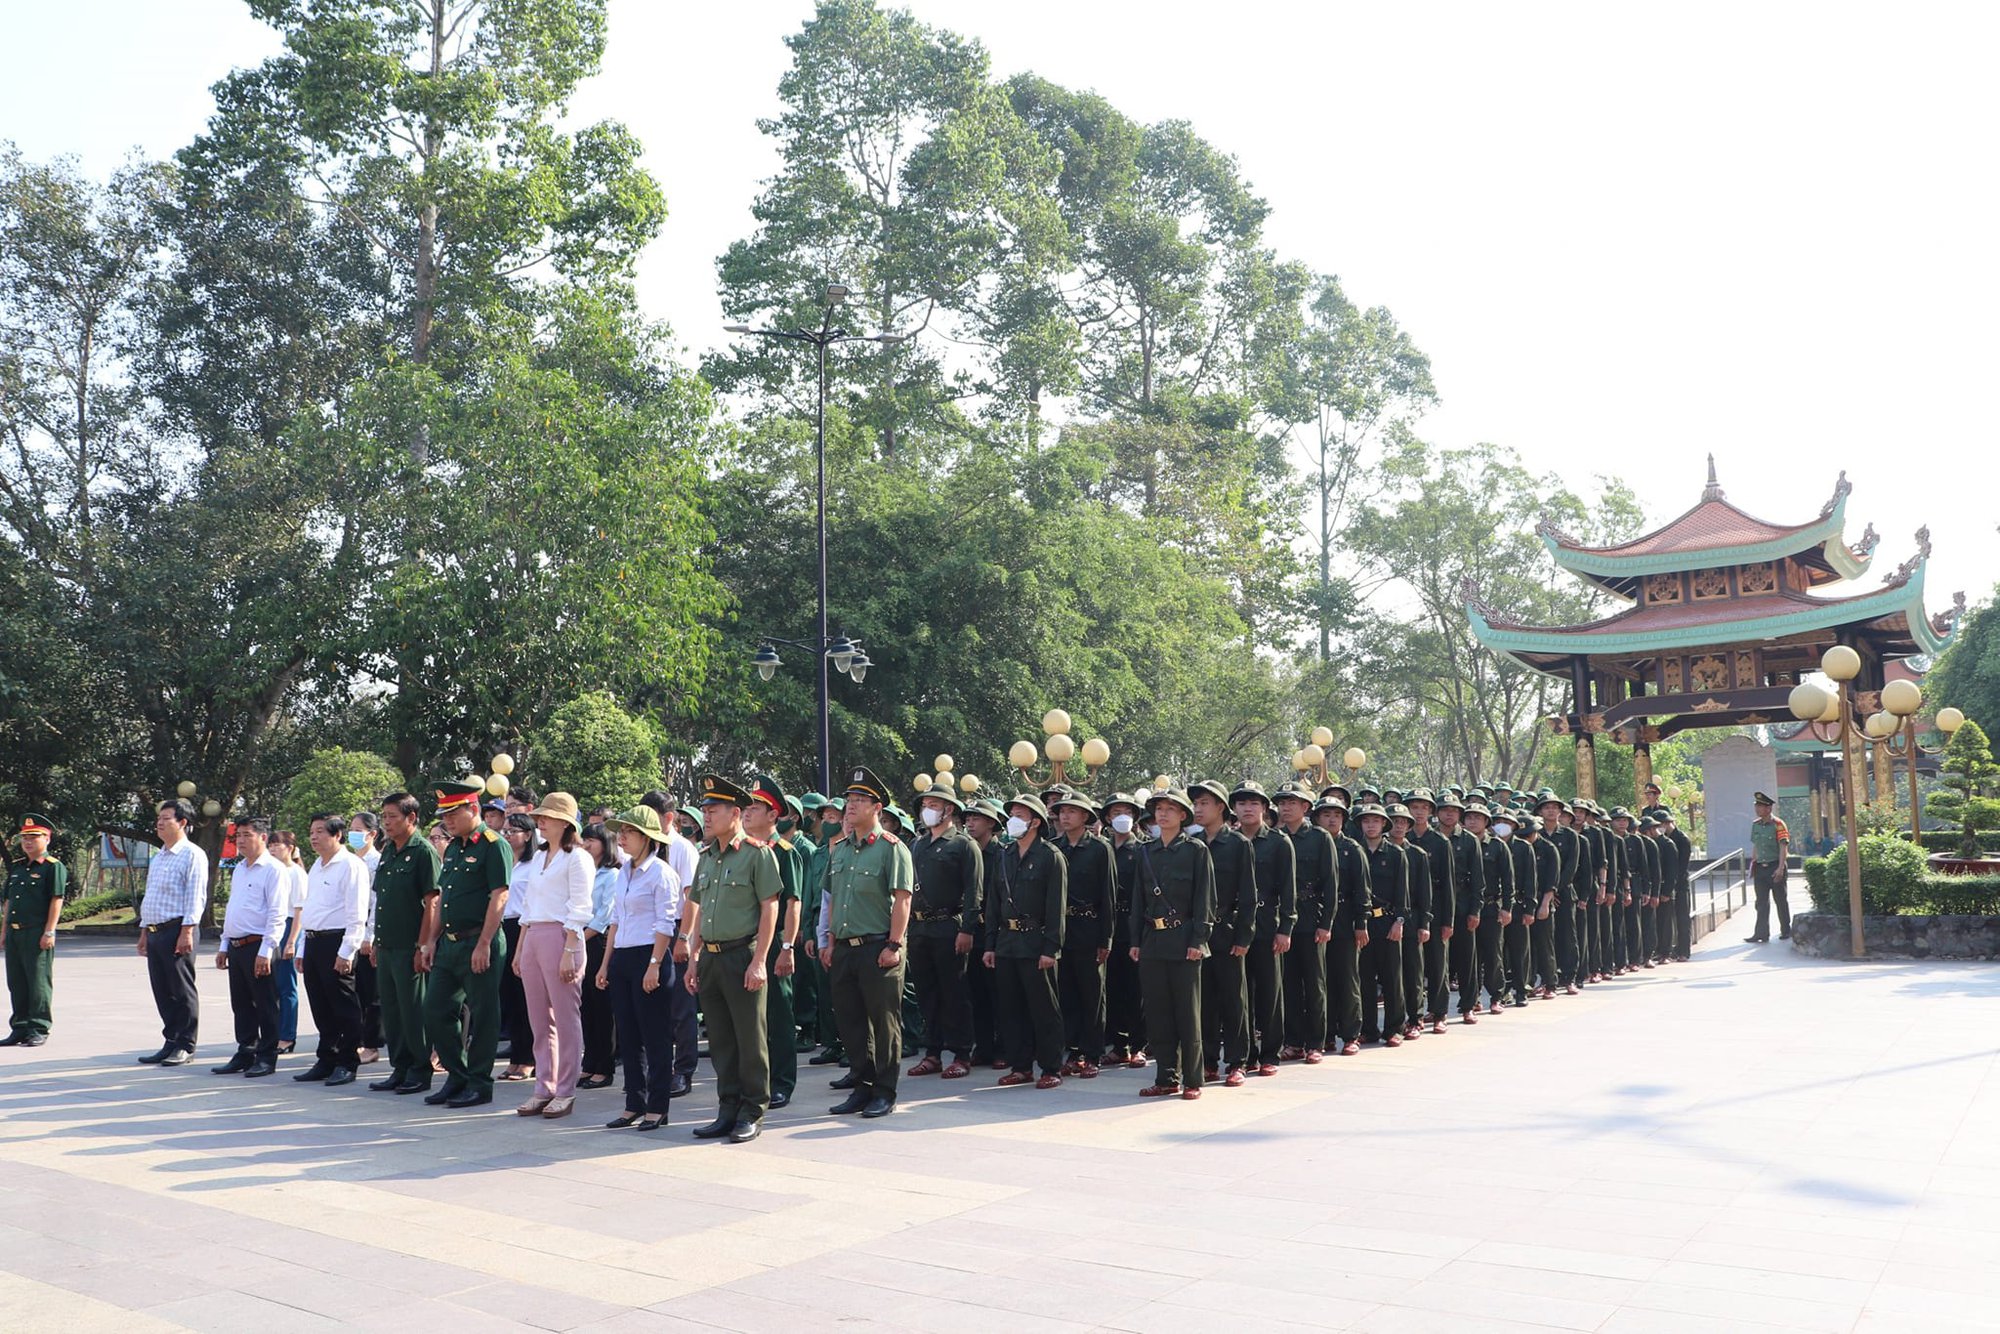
596, 806, 680, 1130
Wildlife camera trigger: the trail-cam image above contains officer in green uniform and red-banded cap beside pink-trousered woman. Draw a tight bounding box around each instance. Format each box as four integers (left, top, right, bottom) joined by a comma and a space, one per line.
420, 782, 512, 1108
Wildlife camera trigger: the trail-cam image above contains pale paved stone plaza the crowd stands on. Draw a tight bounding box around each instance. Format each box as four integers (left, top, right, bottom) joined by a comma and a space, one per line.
0, 896, 2000, 1334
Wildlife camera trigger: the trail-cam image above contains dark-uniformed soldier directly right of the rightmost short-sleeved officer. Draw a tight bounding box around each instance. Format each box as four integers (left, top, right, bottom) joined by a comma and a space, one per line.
910, 782, 986, 1080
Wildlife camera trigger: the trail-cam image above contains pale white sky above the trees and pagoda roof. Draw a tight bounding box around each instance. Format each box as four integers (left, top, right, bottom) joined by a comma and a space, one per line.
0, 0, 2000, 610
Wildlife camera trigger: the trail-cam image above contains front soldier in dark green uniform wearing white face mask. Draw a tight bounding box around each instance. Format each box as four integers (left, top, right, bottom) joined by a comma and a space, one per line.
984, 792, 1068, 1088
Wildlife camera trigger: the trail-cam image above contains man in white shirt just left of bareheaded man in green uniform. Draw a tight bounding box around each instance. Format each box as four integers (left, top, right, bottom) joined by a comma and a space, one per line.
292, 814, 368, 1088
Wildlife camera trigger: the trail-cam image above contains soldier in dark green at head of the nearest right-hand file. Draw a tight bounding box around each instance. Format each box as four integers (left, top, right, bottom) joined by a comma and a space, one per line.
1130, 790, 1216, 1098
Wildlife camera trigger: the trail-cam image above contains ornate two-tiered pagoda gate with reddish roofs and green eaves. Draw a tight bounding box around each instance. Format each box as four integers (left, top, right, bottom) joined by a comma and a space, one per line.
1460, 454, 1966, 798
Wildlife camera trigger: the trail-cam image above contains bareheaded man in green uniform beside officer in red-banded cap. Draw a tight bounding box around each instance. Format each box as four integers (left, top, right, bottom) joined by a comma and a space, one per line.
368, 792, 444, 1094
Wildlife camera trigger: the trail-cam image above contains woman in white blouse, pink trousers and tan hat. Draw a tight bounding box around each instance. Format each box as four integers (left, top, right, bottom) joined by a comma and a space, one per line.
512, 792, 596, 1120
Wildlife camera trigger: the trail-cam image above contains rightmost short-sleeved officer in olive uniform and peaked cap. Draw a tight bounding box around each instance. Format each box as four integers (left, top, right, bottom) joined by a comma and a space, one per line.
820, 768, 916, 1118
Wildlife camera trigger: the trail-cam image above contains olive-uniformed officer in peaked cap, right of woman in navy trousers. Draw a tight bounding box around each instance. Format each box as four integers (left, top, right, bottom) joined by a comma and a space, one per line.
684, 774, 784, 1144
